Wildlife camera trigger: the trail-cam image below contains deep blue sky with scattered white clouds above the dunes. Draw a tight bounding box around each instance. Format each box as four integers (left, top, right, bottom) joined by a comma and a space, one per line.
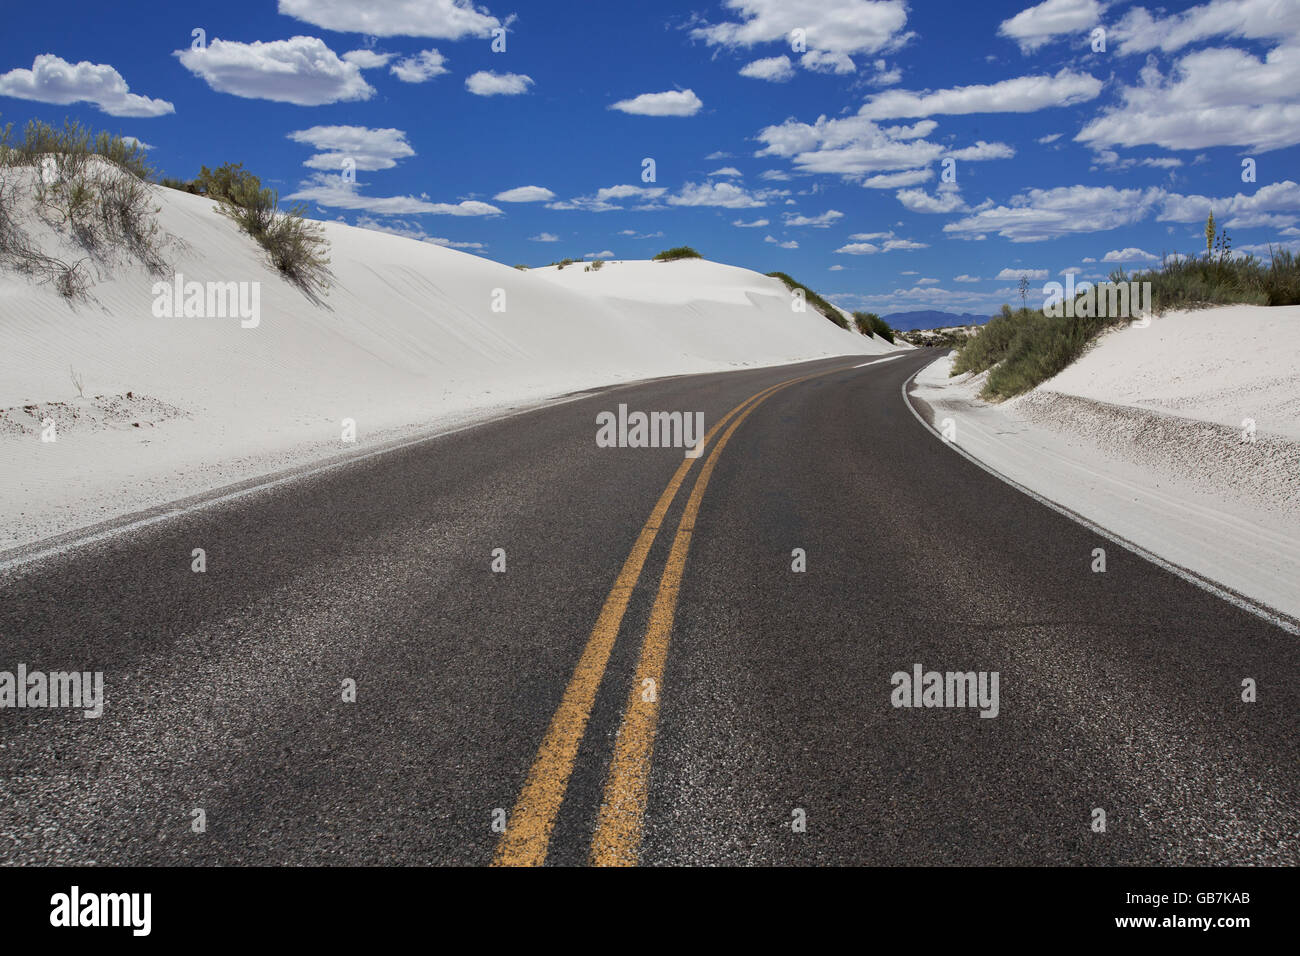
0, 0, 1300, 319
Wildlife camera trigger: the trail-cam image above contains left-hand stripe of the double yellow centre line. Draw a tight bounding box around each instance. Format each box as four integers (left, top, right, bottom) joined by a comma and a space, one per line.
493, 378, 801, 866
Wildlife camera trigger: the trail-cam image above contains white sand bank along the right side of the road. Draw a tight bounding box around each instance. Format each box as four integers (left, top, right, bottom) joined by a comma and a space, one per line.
914, 306, 1300, 618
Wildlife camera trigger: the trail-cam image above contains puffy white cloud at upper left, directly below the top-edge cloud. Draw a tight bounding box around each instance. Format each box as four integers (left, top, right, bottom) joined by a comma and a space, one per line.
176, 36, 374, 107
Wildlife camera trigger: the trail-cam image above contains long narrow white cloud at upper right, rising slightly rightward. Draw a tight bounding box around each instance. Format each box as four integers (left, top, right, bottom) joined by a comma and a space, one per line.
858, 69, 1101, 120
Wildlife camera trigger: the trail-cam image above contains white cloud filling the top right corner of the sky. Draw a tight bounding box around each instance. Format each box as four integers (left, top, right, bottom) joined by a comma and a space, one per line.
1113, 0, 1300, 53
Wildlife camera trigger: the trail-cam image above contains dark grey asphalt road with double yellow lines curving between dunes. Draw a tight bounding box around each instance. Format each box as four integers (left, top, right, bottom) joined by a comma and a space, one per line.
0, 352, 1300, 865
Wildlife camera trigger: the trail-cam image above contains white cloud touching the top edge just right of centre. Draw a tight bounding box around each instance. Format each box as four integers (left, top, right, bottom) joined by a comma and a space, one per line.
690, 0, 907, 53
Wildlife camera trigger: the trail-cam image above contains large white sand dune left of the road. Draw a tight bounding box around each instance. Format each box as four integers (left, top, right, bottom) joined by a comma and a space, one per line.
0, 169, 891, 549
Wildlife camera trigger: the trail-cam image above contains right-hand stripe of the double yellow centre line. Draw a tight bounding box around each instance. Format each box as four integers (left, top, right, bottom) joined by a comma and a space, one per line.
592, 358, 845, 866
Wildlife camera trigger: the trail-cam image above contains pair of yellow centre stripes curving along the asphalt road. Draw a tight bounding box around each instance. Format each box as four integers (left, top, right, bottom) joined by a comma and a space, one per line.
493, 368, 842, 866
